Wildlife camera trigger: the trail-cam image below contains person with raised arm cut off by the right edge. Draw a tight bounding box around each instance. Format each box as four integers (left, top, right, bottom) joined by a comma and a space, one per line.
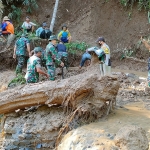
141, 37, 150, 87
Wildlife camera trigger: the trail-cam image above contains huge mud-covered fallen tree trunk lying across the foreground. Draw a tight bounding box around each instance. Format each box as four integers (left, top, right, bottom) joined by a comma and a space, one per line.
0, 72, 119, 114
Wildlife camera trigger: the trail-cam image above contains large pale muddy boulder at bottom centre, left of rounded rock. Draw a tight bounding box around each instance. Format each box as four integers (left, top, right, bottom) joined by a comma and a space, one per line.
58, 126, 119, 150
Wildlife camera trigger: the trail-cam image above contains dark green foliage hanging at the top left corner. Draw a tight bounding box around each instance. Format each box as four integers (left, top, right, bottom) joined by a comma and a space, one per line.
2, 0, 38, 22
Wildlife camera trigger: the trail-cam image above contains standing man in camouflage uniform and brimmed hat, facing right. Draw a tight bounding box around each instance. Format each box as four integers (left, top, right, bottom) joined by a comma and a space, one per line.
46, 35, 64, 81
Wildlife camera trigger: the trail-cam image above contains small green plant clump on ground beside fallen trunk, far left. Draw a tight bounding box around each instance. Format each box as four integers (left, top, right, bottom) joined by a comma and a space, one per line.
8, 74, 26, 87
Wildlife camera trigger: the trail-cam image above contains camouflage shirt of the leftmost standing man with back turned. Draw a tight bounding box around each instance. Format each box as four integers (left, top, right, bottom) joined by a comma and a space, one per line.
15, 37, 30, 56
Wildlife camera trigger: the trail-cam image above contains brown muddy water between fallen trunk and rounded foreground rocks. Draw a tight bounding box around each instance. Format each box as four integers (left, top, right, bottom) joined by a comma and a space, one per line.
88, 102, 150, 150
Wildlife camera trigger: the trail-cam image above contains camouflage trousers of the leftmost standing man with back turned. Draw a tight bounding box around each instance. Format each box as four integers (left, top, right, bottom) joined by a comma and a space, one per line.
16, 56, 25, 75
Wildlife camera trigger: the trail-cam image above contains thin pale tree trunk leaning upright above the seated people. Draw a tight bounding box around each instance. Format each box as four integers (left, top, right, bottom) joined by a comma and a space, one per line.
50, 0, 59, 32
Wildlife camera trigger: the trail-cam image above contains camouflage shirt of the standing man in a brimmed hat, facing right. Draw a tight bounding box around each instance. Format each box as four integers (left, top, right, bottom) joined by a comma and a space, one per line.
46, 43, 61, 65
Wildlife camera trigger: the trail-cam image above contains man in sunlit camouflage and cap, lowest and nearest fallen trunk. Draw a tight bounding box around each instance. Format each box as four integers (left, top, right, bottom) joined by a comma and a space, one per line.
25, 47, 49, 83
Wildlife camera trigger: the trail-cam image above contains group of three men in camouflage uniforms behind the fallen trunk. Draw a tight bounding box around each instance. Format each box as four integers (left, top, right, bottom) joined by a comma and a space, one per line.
13, 34, 64, 83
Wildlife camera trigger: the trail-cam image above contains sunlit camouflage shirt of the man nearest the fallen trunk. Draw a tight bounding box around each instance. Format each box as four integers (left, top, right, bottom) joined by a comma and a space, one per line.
25, 55, 41, 83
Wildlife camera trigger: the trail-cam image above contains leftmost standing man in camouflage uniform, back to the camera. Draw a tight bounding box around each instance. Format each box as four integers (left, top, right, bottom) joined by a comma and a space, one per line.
13, 34, 31, 75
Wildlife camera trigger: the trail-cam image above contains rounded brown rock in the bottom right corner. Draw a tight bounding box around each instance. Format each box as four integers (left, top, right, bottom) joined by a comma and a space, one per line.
115, 125, 149, 150
